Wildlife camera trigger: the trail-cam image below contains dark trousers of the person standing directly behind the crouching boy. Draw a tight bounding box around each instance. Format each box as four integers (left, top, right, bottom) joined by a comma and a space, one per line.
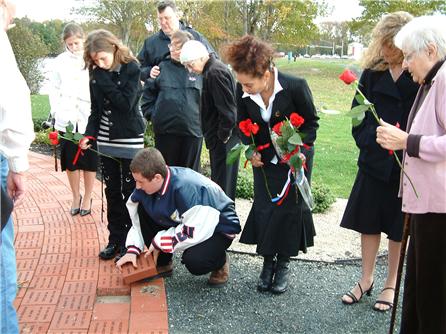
155, 134, 203, 172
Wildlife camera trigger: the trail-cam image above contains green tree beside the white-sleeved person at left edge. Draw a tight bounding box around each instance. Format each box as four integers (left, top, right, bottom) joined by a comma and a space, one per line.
8, 18, 48, 94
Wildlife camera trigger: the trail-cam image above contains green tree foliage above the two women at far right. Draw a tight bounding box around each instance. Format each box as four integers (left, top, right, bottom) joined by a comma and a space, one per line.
350, 0, 446, 43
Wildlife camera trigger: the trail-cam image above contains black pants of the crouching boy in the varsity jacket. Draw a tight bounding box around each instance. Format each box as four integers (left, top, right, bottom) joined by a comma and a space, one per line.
138, 205, 232, 275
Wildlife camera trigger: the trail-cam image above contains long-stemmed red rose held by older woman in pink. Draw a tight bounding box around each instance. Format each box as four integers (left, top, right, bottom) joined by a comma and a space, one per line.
339, 69, 418, 198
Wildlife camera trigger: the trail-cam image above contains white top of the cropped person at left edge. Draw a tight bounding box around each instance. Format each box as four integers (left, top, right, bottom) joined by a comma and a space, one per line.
0, 28, 34, 172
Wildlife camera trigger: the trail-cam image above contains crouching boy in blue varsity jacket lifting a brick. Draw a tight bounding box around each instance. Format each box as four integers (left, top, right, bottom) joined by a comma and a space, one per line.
116, 148, 241, 286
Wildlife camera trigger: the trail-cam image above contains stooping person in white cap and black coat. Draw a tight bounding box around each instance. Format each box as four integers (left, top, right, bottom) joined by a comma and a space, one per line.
180, 41, 239, 199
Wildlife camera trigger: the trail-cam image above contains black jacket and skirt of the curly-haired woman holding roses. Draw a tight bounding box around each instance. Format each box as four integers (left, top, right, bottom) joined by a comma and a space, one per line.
237, 72, 319, 256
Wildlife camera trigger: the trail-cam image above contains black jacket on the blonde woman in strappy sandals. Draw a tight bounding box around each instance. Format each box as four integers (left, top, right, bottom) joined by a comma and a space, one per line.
352, 69, 419, 181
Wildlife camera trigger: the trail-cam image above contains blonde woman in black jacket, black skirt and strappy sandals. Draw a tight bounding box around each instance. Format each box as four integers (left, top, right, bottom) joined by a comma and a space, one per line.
341, 12, 418, 312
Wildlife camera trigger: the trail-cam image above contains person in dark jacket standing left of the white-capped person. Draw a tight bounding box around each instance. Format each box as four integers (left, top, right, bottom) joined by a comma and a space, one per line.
141, 30, 203, 172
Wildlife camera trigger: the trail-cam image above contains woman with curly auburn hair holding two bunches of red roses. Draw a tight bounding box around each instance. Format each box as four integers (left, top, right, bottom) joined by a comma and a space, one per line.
225, 36, 319, 293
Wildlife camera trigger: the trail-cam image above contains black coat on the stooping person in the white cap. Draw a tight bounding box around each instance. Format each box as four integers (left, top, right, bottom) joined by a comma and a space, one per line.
201, 55, 237, 150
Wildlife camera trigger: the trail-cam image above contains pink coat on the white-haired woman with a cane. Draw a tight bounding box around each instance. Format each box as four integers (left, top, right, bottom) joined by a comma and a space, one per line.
401, 63, 446, 214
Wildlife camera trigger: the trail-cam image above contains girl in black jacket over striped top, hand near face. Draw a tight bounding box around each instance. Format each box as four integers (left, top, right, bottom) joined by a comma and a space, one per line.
80, 30, 145, 260
